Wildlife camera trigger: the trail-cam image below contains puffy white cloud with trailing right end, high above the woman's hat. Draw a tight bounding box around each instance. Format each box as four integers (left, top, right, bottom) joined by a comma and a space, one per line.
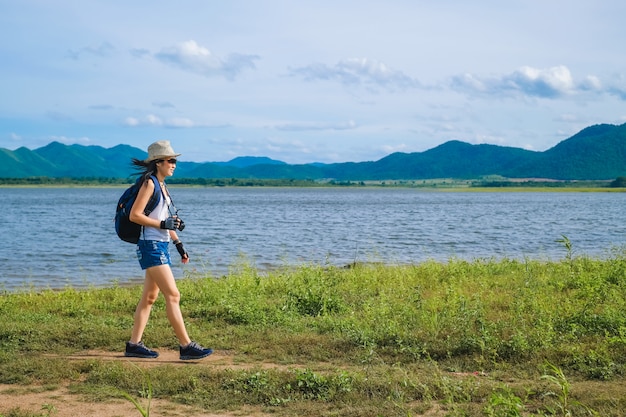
154, 40, 260, 80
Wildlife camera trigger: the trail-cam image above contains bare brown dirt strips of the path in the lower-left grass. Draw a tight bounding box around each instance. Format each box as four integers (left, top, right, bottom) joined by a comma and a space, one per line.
0, 350, 270, 417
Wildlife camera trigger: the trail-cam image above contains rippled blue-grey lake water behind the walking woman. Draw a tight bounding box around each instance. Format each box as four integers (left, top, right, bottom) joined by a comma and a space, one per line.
0, 187, 626, 289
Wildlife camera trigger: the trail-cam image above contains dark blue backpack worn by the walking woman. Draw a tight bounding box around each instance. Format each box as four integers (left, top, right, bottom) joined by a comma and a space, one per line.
115, 175, 161, 243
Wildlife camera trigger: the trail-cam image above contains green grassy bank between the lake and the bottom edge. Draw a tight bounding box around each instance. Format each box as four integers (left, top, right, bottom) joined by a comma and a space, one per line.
0, 247, 626, 417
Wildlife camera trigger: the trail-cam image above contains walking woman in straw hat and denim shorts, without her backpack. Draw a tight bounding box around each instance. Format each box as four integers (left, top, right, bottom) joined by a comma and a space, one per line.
125, 140, 213, 360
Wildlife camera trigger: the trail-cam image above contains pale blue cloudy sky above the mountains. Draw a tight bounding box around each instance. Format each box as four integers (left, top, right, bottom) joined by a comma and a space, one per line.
0, 0, 626, 164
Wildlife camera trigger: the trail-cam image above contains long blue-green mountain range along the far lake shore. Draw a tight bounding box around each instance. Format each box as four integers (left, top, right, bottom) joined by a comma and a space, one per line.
0, 120, 626, 181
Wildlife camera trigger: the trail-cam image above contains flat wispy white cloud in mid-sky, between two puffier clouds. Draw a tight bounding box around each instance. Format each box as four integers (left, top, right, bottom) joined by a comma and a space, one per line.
289, 58, 420, 92
